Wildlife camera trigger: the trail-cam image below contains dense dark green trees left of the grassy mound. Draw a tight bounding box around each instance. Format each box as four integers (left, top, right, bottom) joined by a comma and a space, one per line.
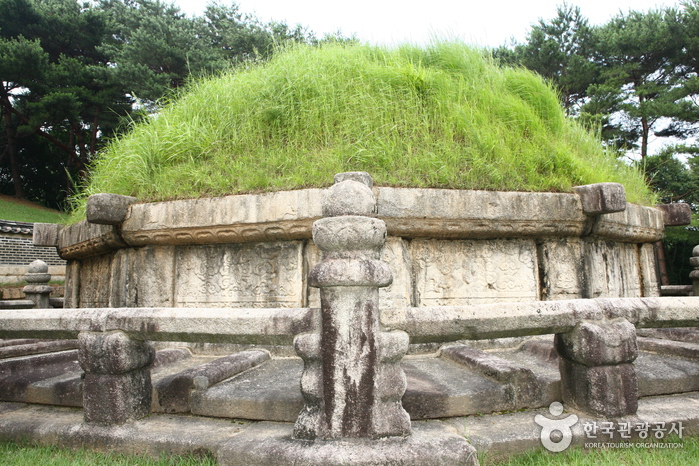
0, 0, 315, 207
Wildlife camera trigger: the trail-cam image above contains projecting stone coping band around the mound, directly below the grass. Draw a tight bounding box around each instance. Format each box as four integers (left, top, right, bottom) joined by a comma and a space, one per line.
53, 187, 664, 259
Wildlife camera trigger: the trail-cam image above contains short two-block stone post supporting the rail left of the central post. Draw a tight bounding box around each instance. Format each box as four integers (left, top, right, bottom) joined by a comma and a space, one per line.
78, 331, 155, 425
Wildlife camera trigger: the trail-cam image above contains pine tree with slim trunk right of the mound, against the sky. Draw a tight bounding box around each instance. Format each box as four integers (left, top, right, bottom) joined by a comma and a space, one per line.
584, 8, 699, 159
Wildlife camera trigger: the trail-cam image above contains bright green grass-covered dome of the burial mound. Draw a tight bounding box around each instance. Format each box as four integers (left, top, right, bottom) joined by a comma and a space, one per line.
69, 43, 651, 218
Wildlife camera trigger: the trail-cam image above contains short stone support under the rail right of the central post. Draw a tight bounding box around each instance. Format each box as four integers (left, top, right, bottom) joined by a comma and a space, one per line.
555, 319, 638, 417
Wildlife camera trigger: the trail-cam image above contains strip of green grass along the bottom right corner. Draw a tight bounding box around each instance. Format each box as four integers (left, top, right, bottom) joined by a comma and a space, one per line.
479, 437, 699, 466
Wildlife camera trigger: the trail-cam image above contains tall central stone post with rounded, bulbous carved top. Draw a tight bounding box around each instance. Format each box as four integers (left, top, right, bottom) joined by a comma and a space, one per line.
294, 172, 410, 439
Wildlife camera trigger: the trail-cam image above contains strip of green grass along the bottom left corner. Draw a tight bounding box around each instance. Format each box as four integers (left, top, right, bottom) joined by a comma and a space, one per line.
0, 442, 216, 466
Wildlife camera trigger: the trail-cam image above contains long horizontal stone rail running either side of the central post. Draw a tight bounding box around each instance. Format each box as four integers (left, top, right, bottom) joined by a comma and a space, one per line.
0, 297, 699, 344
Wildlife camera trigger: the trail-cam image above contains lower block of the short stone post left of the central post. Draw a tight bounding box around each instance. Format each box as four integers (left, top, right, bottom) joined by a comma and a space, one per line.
83, 368, 153, 425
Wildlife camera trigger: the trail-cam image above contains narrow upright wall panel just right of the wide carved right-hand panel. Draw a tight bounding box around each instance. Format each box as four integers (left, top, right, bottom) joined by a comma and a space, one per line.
539, 238, 585, 300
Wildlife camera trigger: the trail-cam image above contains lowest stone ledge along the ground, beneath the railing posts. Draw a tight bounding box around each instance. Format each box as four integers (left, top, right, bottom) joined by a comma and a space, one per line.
0, 392, 699, 465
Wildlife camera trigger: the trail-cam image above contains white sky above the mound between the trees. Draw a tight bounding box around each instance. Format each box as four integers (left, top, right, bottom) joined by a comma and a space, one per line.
174, 0, 680, 47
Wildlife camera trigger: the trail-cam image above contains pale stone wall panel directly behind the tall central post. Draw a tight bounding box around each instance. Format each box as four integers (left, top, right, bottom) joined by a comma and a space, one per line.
305, 236, 412, 309
